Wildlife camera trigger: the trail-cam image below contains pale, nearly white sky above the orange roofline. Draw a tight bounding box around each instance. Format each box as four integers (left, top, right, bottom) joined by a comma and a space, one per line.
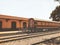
0, 0, 59, 20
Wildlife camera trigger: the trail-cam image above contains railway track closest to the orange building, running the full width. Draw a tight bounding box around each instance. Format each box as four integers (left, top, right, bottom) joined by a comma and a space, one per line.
0, 31, 60, 43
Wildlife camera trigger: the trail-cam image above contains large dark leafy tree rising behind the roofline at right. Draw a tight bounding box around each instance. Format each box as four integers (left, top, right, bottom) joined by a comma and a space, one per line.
50, 6, 60, 21
